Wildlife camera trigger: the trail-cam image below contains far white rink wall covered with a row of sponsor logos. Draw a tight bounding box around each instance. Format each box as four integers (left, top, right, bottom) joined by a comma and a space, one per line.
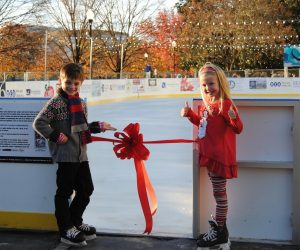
1, 77, 300, 102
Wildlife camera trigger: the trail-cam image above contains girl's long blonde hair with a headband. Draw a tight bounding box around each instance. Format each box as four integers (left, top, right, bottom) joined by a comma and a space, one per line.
199, 62, 234, 112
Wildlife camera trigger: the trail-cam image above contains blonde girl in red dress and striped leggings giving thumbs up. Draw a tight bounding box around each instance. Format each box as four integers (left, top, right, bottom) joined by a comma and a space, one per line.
181, 63, 243, 249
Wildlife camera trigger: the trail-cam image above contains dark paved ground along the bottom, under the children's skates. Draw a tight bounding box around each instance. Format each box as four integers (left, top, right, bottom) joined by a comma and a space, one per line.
0, 231, 300, 250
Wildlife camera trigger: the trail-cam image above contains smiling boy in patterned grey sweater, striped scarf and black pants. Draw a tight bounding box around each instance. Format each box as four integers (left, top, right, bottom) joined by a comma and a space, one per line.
33, 63, 116, 246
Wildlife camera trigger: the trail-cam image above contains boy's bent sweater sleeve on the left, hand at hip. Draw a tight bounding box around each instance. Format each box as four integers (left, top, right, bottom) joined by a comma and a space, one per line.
32, 100, 60, 142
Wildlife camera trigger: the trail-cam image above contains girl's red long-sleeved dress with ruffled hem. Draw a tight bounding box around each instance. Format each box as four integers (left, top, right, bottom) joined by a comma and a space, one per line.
187, 99, 243, 179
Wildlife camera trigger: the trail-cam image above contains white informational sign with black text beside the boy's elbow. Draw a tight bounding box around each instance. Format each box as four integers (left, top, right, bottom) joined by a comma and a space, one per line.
0, 98, 52, 163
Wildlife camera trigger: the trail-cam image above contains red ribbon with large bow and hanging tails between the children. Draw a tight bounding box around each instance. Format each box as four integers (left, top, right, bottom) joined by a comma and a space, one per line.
92, 123, 196, 234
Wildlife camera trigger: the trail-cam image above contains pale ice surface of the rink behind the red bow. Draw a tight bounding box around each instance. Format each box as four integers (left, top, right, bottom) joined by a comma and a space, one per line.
84, 98, 193, 237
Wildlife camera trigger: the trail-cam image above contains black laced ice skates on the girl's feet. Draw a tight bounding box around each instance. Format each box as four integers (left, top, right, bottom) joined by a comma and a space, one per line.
197, 216, 230, 250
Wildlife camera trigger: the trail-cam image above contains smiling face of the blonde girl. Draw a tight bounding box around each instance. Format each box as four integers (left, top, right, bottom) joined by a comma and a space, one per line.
200, 74, 220, 102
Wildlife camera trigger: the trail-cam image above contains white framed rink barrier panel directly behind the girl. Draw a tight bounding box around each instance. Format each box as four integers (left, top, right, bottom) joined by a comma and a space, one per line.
193, 99, 300, 244
